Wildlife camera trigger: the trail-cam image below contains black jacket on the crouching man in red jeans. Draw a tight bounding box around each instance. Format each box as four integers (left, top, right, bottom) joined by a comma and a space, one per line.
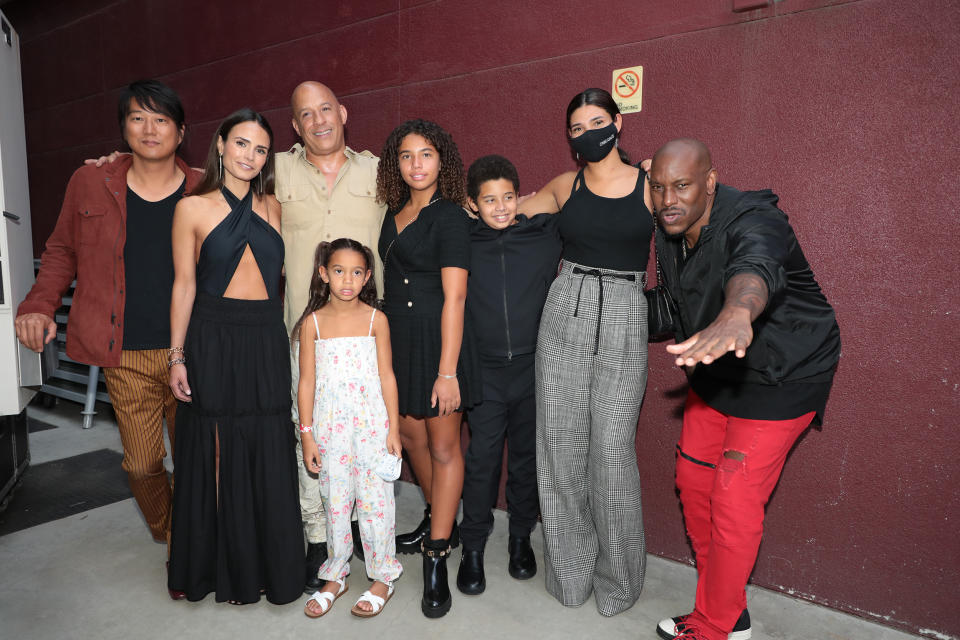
657, 184, 840, 419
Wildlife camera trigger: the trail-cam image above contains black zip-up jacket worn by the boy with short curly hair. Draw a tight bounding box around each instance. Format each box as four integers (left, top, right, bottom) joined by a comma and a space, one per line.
467, 214, 561, 365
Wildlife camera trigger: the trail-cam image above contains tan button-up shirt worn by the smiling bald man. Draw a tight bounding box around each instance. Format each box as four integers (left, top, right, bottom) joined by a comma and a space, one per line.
276, 143, 387, 332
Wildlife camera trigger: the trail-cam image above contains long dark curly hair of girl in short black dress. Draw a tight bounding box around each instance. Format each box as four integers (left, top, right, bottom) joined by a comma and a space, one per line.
377, 120, 466, 210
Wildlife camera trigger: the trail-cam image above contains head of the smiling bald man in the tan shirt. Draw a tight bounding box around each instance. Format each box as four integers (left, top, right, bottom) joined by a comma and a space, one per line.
290, 80, 347, 161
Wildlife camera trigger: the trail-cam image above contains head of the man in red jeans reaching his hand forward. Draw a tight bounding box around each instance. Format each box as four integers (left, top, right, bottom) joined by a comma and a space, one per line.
650, 138, 717, 247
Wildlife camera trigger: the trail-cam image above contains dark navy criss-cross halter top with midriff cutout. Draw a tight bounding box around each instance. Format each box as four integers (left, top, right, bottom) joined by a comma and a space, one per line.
197, 187, 283, 300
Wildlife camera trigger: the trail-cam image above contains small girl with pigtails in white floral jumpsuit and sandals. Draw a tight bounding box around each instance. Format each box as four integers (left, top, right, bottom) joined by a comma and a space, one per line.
293, 238, 403, 618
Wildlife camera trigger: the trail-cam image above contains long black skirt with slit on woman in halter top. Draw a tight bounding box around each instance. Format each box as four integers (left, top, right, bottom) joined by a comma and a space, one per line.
168, 293, 304, 604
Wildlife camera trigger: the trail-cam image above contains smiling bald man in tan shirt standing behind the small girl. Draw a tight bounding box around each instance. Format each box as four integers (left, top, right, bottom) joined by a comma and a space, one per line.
276, 82, 386, 593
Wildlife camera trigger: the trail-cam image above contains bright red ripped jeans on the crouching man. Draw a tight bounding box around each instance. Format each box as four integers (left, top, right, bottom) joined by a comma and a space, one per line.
677, 389, 814, 640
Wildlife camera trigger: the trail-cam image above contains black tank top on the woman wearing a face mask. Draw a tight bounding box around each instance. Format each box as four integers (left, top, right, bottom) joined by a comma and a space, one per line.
559, 169, 653, 271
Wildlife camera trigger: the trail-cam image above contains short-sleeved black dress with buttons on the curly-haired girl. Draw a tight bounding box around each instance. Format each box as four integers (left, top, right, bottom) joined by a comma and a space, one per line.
378, 199, 482, 417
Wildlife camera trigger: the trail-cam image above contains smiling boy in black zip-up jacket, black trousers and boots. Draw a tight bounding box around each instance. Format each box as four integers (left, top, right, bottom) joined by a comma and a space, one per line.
457, 156, 561, 595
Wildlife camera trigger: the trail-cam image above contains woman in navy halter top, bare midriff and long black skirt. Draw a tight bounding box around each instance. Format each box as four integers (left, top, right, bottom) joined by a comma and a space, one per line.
168, 109, 303, 604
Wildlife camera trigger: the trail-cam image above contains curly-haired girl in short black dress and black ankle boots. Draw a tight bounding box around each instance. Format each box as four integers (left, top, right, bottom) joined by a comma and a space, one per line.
377, 120, 481, 618
